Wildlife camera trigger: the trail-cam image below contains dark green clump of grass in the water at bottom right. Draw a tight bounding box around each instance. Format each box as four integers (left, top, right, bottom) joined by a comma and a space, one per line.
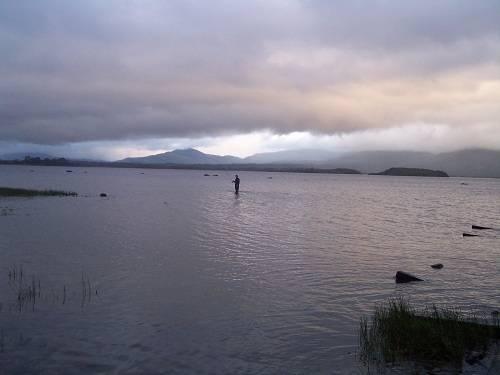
359, 298, 500, 365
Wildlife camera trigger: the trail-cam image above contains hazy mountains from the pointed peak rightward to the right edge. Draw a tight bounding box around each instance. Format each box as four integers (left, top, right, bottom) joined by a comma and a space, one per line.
118, 149, 500, 178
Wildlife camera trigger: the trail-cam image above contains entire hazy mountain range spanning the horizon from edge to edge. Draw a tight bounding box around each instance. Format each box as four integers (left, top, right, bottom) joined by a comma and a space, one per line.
0, 149, 500, 178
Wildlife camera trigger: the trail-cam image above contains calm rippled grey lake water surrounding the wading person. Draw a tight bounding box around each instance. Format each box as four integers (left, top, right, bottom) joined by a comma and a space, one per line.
0, 166, 500, 374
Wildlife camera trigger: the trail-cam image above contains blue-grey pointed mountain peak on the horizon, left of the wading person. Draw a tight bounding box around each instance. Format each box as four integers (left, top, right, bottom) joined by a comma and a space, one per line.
118, 148, 242, 164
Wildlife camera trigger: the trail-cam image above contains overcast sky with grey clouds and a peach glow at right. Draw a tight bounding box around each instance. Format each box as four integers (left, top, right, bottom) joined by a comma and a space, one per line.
0, 0, 500, 159
